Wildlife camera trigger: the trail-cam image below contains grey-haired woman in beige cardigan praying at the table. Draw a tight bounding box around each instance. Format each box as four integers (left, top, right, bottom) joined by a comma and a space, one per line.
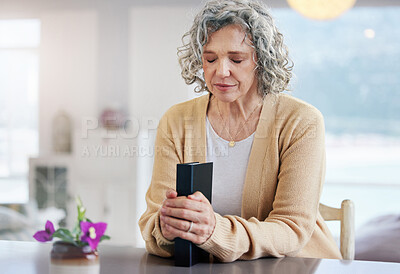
139, 0, 341, 262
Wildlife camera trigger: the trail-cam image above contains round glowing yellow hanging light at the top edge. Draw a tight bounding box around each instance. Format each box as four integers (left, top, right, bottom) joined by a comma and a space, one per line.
287, 0, 356, 20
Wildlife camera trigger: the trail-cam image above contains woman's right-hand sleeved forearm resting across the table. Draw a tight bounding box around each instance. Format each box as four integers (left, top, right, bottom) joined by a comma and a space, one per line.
199, 214, 312, 262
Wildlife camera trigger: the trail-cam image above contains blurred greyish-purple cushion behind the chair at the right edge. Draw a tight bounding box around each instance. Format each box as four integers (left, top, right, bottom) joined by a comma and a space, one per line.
355, 214, 400, 262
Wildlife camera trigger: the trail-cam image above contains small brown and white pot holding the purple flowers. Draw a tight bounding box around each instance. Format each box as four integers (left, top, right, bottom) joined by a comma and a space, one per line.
50, 241, 100, 274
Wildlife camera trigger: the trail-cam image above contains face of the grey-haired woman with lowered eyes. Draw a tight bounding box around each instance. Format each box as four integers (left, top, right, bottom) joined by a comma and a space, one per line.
203, 25, 257, 103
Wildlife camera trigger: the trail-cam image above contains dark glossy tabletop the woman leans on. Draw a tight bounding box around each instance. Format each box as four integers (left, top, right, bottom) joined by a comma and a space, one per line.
0, 241, 400, 274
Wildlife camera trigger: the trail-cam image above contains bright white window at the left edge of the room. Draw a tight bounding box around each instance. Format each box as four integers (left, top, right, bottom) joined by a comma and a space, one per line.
0, 19, 40, 203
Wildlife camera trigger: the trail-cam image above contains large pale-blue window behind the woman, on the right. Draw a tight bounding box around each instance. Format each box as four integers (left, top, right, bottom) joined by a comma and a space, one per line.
272, 7, 400, 232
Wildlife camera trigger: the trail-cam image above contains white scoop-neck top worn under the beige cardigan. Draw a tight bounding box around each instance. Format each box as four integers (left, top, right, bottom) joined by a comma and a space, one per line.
206, 117, 254, 216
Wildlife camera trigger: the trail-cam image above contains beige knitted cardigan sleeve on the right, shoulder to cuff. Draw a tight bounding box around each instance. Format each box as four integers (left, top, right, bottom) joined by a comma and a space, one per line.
200, 107, 325, 262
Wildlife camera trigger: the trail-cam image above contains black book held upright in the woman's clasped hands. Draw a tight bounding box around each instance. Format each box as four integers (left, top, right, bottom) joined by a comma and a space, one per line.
175, 162, 213, 266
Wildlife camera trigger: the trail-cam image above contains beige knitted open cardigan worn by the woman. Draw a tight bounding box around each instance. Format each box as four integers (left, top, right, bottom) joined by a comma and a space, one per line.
139, 94, 341, 262
